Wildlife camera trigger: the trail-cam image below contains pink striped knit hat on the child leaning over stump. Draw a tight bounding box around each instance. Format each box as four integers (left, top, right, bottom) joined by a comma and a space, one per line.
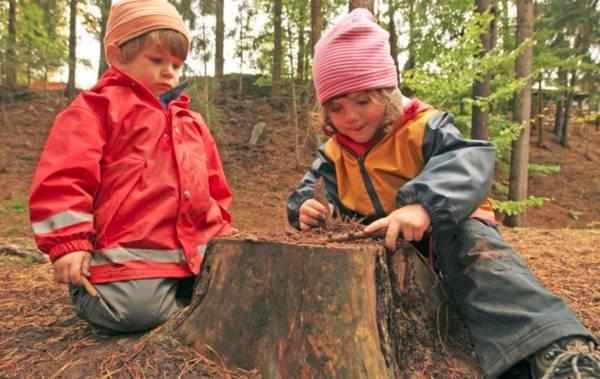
313, 8, 398, 105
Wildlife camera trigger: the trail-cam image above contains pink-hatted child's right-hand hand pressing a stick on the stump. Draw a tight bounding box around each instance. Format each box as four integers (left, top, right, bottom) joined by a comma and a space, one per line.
365, 204, 431, 250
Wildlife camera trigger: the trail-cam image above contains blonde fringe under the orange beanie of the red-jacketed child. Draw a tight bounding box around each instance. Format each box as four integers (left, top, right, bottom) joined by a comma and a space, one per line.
120, 29, 189, 64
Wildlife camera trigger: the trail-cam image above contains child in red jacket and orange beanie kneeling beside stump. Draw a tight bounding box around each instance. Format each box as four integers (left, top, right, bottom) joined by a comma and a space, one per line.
29, 0, 231, 332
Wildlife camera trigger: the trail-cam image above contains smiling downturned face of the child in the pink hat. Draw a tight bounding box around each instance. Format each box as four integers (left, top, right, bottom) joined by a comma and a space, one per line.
325, 91, 385, 143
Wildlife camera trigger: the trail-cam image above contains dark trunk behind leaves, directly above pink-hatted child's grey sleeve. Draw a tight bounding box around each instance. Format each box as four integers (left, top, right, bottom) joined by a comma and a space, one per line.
471, 0, 492, 140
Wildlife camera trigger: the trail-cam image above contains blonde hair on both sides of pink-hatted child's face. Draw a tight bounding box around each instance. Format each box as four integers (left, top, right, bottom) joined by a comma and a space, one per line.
310, 88, 403, 137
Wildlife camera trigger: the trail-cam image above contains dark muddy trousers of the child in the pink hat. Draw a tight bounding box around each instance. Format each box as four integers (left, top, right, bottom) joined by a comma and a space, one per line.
434, 219, 593, 378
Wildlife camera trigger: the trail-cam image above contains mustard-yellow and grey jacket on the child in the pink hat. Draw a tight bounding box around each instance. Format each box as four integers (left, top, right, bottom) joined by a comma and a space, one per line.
287, 100, 495, 233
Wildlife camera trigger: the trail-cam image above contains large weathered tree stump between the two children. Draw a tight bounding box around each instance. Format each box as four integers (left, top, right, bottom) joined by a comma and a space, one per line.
176, 239, 474, 378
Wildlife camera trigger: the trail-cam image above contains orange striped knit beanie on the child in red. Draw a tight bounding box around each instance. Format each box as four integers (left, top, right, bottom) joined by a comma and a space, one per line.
104, 0, 190, 55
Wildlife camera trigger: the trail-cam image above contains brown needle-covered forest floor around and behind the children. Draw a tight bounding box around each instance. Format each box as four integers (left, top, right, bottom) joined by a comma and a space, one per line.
0, 87, 600, 378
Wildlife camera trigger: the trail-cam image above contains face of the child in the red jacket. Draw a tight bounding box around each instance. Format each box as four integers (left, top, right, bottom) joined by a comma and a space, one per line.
116, 43, 183, 96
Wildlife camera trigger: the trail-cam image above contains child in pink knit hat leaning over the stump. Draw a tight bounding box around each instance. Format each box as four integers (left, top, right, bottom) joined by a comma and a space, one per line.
288, 9, 600, 378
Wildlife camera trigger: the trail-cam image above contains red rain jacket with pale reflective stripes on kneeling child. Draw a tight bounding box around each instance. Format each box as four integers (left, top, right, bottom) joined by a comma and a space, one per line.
30, 67, 231, 283
